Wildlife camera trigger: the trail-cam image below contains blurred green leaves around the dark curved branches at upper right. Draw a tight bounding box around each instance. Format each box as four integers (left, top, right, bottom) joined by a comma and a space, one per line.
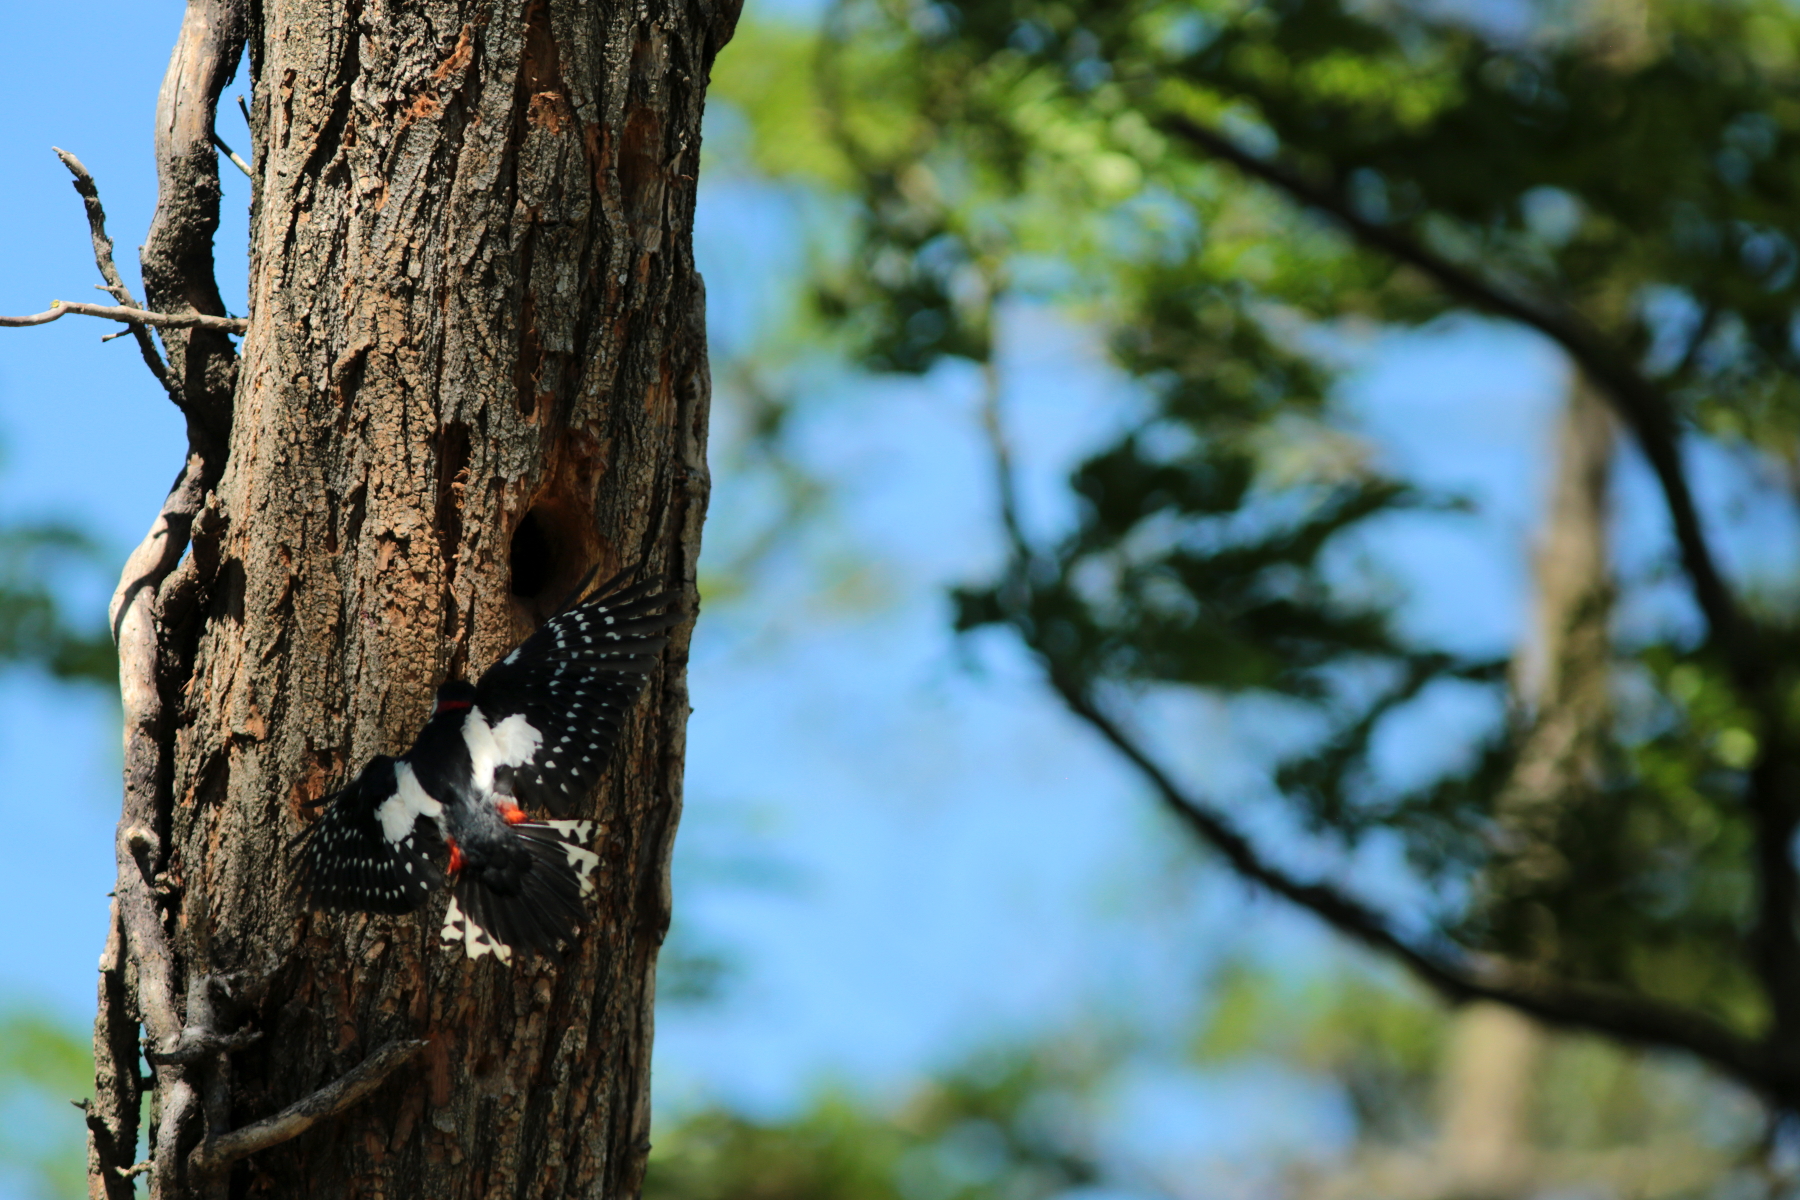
718, 0, 1800, 1079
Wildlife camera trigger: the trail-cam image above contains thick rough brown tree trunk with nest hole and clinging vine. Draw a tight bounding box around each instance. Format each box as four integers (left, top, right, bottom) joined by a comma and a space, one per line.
68, 0, 742, 1200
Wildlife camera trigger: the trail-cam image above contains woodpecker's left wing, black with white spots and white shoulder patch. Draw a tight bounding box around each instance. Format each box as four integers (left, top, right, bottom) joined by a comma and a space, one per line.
301, 756, 443, 912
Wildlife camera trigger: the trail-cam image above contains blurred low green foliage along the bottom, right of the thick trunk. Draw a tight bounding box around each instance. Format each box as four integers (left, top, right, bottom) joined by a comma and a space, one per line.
644, 961, 1760, 1200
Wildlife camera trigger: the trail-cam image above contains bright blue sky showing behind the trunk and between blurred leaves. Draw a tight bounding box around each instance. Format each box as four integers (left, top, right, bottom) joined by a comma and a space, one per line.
0, 2, 1728, 1194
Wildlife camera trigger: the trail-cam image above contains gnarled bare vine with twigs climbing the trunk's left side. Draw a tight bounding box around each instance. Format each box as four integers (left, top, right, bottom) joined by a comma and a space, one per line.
85, 0, 248, 1200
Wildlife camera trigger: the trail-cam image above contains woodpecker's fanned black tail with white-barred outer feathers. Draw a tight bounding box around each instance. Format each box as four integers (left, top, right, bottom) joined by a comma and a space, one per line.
441, 820, 599, 963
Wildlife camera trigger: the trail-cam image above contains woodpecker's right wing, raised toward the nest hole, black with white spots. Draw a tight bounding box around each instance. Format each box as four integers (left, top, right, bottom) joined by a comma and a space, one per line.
466, 576, 680, 817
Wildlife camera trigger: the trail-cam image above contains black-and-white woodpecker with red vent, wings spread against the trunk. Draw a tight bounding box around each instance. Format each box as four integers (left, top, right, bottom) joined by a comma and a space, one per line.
299, 570, 680, 963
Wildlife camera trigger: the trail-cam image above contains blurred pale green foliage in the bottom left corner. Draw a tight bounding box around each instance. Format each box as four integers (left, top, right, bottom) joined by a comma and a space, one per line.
0, 1007, 94, 1200
